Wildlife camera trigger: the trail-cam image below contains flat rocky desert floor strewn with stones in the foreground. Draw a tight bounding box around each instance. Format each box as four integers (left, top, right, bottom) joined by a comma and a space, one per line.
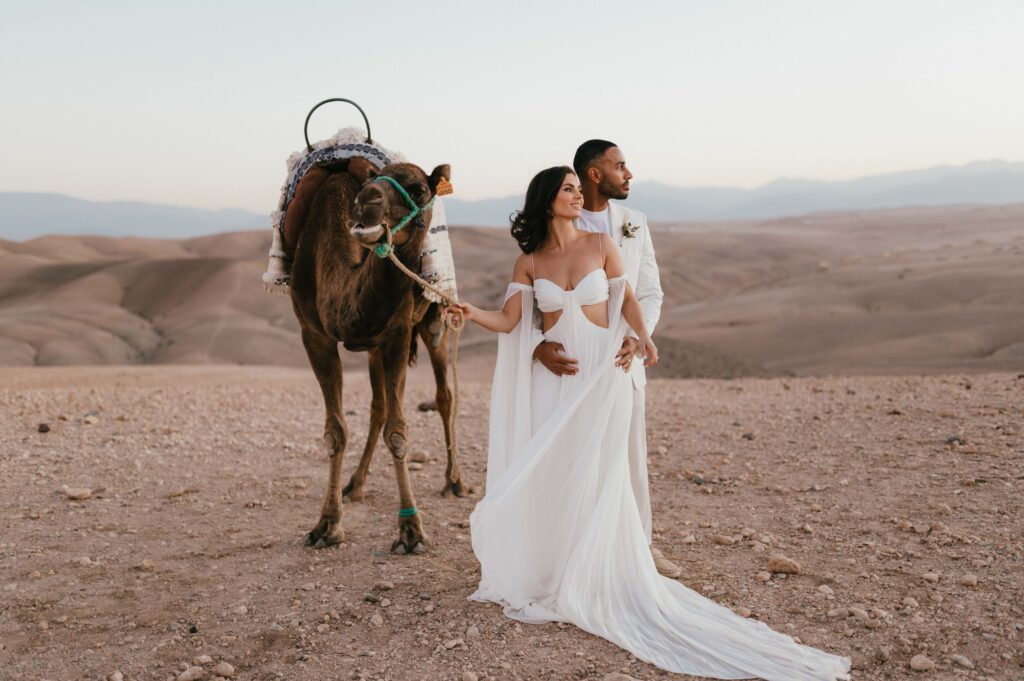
0, 366, 1024, 681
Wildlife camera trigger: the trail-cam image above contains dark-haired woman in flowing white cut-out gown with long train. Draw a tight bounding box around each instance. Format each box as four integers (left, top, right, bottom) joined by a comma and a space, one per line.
449, 166, 850, 681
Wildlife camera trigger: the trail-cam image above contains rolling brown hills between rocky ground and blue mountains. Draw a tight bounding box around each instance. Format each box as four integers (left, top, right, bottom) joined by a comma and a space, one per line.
0, 204, 1024, 380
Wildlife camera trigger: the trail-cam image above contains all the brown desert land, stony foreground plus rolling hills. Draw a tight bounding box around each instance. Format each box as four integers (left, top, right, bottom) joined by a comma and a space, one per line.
0, 205, 1024, 681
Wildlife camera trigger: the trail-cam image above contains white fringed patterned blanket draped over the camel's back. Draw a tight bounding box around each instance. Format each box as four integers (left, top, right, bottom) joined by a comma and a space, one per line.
263, 127, 458, 302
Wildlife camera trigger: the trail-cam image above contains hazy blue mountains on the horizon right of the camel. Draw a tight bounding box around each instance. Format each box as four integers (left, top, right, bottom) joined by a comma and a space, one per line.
444, 160, 1024, 226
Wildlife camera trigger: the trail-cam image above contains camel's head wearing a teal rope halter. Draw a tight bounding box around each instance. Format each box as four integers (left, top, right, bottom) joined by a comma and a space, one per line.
349, 163, 452, 247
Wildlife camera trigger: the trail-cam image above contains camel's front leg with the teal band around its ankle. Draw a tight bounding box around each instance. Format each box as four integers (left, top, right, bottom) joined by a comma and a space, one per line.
381, 329, 430, 554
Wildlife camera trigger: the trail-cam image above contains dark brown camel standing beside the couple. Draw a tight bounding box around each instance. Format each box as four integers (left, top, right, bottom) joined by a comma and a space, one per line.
284, 157, 472, 554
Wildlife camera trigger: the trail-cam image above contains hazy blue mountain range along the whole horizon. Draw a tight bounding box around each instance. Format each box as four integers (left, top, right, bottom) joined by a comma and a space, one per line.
0, 160, 1024, 241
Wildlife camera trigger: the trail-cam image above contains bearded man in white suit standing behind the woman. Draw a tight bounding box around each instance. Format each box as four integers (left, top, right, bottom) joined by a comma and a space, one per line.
534, 139, 680, 578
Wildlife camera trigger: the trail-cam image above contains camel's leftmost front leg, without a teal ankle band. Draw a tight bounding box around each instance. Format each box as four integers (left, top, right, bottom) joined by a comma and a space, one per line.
302, 329, 348, 549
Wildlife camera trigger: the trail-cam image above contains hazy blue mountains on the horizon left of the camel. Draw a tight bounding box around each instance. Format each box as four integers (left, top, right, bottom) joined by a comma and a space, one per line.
0, 191, 270, 241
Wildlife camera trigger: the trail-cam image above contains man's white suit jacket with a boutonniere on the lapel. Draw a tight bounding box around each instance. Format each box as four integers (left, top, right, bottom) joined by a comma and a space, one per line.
530, 201, 665, 388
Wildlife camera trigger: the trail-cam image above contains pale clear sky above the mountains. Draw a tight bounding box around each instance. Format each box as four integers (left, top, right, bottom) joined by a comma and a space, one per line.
0, 0, 1024, 212
